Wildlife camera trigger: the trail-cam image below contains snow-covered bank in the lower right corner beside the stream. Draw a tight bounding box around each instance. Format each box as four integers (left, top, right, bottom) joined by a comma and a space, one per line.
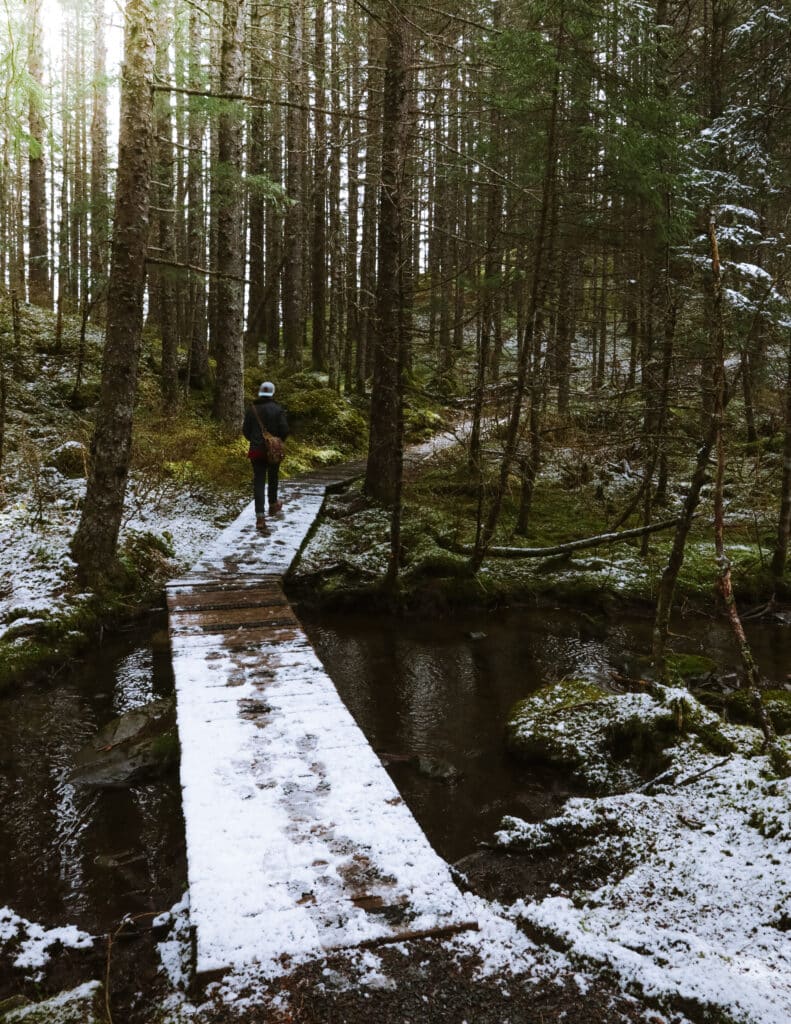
498, 752, 791, 1024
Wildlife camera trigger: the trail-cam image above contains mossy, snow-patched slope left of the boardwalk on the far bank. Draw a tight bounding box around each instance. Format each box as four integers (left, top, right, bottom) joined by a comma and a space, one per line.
0, 296, 454, 692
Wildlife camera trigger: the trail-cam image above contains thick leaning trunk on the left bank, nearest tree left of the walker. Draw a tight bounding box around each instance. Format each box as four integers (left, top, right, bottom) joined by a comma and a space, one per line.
72, 0, 155, 583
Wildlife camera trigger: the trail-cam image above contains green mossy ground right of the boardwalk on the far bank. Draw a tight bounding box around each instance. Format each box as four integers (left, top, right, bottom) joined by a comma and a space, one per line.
294, 421, 788, 610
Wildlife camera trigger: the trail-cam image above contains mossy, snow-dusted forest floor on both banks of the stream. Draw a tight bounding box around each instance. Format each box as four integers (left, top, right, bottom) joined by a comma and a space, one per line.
0, 310, 791, 1024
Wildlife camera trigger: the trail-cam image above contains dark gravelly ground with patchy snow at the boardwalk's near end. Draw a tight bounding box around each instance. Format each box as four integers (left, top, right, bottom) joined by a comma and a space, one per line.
0, 872, 688, 1024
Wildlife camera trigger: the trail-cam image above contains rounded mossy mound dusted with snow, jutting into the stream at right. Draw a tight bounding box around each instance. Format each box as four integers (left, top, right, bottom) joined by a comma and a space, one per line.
506, 679, 733, 793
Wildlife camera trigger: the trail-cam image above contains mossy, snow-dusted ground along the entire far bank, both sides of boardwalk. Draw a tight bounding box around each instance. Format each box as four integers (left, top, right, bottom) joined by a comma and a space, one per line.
0, 302, 791, 686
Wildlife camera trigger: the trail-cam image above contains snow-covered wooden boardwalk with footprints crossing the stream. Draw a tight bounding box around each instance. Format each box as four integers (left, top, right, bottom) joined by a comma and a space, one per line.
167, 440, 474, 975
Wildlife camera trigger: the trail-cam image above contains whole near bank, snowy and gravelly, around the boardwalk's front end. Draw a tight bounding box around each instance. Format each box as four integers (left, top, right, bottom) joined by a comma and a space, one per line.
0, 727, 791, 1024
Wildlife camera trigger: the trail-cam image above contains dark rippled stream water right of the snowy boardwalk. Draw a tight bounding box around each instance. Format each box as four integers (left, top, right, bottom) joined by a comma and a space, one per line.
304, 608, 791, 861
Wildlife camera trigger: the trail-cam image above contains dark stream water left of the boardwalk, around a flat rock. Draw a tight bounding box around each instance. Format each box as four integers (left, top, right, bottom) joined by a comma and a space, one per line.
0, 617, 186, 932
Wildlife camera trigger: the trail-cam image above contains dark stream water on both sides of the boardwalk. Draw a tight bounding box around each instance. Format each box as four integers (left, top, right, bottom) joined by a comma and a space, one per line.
0, 608, 791, 933
